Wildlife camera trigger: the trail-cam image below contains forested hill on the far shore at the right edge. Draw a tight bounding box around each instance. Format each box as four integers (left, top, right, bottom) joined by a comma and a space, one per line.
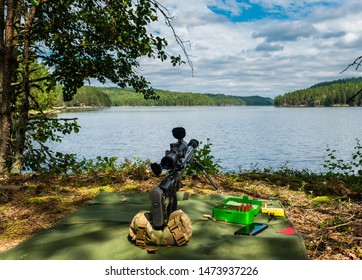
274, 77, 362, 107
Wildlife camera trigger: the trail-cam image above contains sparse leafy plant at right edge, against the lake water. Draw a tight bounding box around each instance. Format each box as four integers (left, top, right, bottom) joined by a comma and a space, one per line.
324, 139, 362, 177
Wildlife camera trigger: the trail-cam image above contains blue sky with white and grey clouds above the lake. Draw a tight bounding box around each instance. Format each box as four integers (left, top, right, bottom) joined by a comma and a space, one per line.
129, 0, 362, 97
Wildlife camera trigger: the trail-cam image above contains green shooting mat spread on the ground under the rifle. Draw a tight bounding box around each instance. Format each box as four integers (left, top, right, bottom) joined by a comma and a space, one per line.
0, 192, 307, 260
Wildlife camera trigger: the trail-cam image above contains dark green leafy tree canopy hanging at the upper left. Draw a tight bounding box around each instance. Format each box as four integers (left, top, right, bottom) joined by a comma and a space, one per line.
33, 0, 181, 101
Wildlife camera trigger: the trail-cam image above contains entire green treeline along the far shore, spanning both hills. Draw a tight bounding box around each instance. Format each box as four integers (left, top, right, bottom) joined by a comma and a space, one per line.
46, 78, 362, 108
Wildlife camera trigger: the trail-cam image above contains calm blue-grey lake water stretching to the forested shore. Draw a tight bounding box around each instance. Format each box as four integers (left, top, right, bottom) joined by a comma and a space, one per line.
56, 106, 362, 172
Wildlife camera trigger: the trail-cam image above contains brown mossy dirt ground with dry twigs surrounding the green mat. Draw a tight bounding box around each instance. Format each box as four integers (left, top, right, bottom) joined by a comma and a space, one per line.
0, 174, 362, 260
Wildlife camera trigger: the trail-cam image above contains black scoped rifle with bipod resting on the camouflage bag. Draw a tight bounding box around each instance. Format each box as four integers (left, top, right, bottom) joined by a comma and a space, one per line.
150, 127, 218, 229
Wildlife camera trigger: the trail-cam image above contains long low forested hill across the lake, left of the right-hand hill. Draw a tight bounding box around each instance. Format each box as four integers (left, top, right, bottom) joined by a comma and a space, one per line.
92, 87, 273, 106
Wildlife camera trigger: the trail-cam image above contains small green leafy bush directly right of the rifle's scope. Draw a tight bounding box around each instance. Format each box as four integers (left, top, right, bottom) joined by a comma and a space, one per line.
187, 139, 221, 175
